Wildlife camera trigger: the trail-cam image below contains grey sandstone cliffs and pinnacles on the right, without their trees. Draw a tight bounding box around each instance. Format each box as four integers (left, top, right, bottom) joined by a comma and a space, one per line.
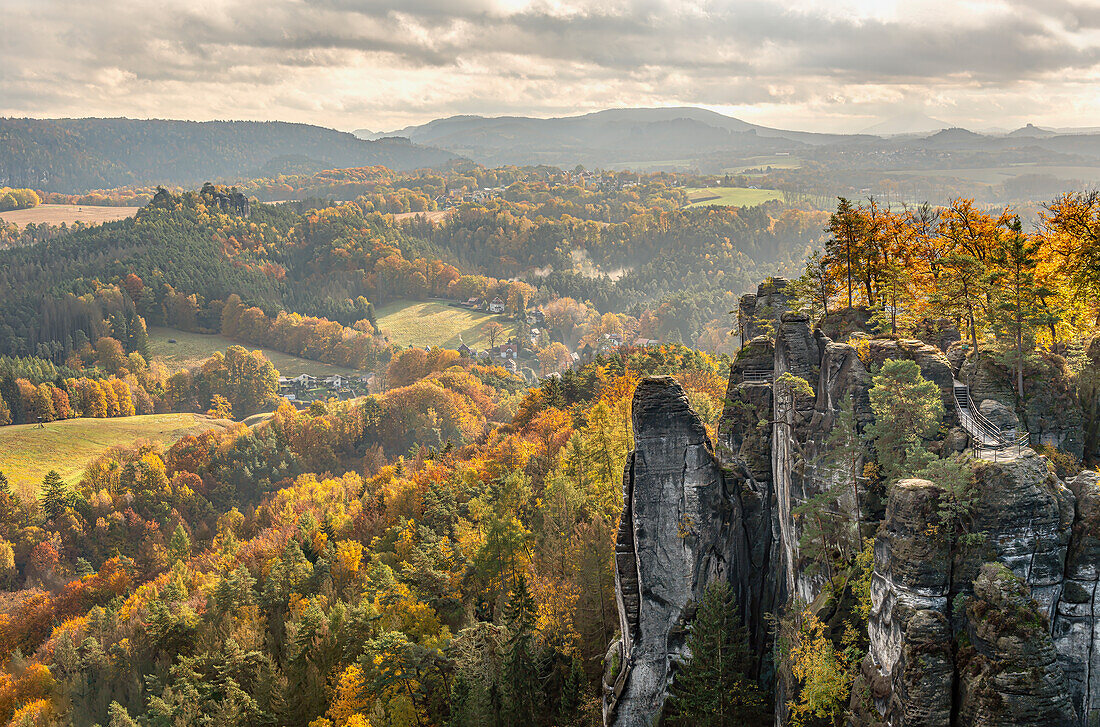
604, 279, 1100, 727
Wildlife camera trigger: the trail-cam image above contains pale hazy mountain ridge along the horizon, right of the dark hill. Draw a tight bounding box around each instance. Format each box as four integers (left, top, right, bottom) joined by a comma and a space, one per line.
355, 107, 1100, 172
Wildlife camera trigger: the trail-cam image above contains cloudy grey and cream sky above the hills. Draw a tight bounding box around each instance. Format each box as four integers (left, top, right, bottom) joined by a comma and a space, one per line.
0, 0, 1100, 132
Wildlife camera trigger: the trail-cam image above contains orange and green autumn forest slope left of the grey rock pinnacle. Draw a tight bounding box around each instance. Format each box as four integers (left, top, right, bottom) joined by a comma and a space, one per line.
0, 340, 724, 727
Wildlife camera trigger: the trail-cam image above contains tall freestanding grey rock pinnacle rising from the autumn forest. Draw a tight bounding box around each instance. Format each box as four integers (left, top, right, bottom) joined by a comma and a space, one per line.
604, 377, 748, 727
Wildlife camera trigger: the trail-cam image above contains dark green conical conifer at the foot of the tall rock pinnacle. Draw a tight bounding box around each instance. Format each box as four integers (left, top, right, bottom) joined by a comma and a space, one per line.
669, 581, 766, 727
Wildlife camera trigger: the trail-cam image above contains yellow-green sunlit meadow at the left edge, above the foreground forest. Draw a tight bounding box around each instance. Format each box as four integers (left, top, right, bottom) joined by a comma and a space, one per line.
0, 414, 232, 493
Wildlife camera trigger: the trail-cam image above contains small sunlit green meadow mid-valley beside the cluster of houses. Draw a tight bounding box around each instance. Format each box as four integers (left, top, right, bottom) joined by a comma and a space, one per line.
375, 300, 517, 349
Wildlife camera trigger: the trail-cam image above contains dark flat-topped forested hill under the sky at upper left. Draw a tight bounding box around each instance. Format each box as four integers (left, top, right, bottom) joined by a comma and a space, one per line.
0, 119, 454, 192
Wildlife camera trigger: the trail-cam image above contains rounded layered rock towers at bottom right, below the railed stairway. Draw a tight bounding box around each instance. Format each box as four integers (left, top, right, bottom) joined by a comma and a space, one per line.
861, 455, 1086, 727
